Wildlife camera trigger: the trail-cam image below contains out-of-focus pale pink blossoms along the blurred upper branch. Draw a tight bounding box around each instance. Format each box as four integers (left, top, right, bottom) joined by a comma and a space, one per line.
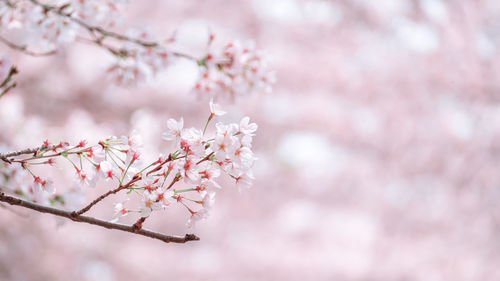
0, 0, 275, 98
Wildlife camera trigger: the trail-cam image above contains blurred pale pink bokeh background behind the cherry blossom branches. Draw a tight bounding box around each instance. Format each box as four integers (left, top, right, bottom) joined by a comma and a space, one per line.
0, 0, 500, 281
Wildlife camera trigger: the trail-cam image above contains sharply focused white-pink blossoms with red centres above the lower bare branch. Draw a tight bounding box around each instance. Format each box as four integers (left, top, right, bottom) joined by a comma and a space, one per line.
0, 101, 257, 225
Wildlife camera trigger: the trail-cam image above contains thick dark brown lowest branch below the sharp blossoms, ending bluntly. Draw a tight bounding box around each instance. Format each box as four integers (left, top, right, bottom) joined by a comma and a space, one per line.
0, 192, 200, 243
